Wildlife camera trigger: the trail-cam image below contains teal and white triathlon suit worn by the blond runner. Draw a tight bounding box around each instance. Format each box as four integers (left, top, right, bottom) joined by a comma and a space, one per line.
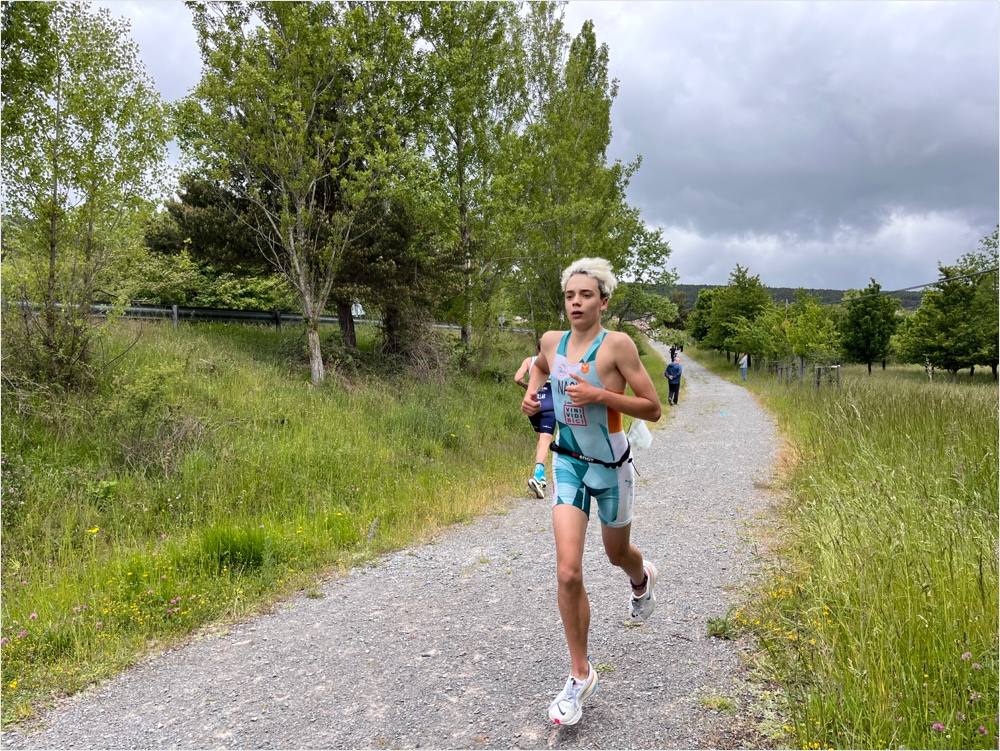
549, 329, 635, 527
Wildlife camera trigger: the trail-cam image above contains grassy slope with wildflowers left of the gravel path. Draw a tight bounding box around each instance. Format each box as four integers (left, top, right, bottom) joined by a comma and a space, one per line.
0, 324, 534, 722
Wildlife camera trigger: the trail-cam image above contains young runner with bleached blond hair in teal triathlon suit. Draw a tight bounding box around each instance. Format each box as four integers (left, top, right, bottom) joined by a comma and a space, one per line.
521, 258, 660, 725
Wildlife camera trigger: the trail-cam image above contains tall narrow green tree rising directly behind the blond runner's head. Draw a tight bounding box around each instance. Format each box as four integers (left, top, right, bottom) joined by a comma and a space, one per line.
510, 7, 675, 332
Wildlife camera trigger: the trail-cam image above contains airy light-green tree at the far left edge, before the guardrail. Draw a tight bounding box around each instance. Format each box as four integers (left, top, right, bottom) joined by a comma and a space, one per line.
3, 3, 168, 384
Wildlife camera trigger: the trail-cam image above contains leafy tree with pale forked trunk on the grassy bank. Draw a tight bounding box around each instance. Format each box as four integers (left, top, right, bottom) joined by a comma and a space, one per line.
182, 2, 410, 384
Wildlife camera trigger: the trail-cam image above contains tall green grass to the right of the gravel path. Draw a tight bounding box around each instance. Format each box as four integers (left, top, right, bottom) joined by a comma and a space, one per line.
692, 351, 998, 748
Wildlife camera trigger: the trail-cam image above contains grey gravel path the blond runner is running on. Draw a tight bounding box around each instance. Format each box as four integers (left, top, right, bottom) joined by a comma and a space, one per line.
2, 346, 777, 749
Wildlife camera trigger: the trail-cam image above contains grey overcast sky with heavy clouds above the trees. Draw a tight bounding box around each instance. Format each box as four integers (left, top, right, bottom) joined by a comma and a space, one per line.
99, 0, 1000, 289
